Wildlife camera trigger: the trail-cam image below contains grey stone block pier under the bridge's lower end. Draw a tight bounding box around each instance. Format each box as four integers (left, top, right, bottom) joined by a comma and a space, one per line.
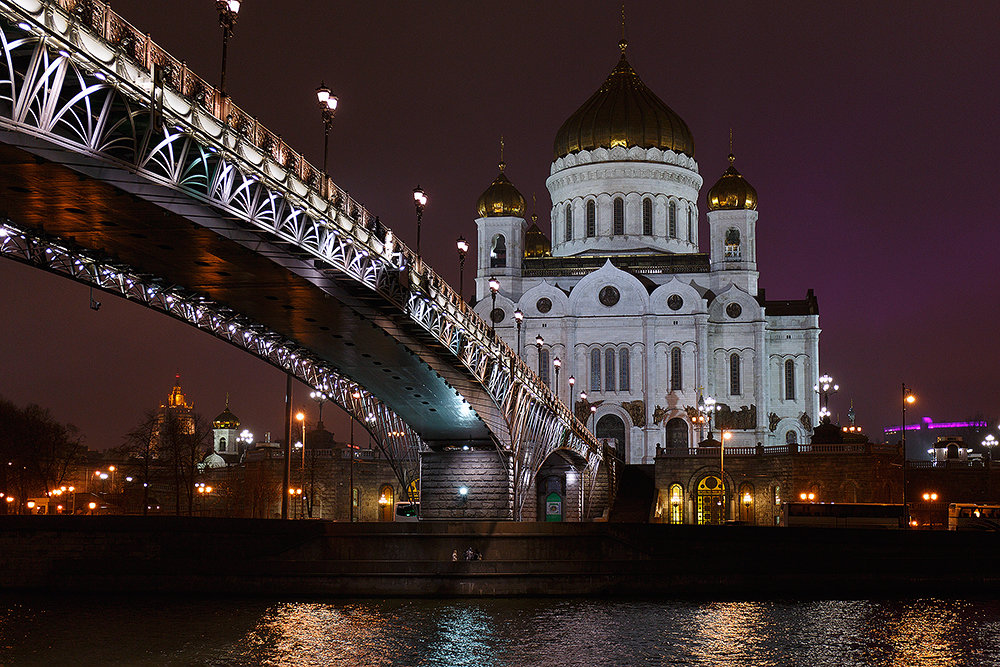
420, 449, 514, 521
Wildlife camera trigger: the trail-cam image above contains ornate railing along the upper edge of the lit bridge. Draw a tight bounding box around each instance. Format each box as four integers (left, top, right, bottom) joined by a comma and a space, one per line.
23, 0, 600, 462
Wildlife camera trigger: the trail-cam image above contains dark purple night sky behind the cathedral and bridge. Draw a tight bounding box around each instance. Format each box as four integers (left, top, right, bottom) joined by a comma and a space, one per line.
0, 0, 1000, 449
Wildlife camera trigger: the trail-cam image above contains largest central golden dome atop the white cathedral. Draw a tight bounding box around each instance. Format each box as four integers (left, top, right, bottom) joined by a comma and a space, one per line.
555, 47, 694, 159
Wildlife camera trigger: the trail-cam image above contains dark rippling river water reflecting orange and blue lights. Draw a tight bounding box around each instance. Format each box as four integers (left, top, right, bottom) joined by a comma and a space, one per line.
0, 593, 1000, 667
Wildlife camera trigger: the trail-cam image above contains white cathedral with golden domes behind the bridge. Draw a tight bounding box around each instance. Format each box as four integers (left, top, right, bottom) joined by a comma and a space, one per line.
476, 42, 820, 463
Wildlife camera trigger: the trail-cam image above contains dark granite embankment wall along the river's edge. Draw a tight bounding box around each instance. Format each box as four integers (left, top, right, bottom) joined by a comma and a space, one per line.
0, 516, 1000, 598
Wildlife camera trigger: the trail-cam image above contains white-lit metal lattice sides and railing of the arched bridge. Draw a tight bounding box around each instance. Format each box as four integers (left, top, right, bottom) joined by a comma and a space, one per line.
0, 0, 615, 517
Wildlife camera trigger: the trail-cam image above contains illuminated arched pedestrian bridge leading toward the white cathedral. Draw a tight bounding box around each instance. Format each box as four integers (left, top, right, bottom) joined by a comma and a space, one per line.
0, 0, 615, 518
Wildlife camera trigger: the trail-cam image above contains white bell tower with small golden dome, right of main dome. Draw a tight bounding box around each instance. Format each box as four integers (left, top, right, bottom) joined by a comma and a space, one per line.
708, 153, 759, 294
